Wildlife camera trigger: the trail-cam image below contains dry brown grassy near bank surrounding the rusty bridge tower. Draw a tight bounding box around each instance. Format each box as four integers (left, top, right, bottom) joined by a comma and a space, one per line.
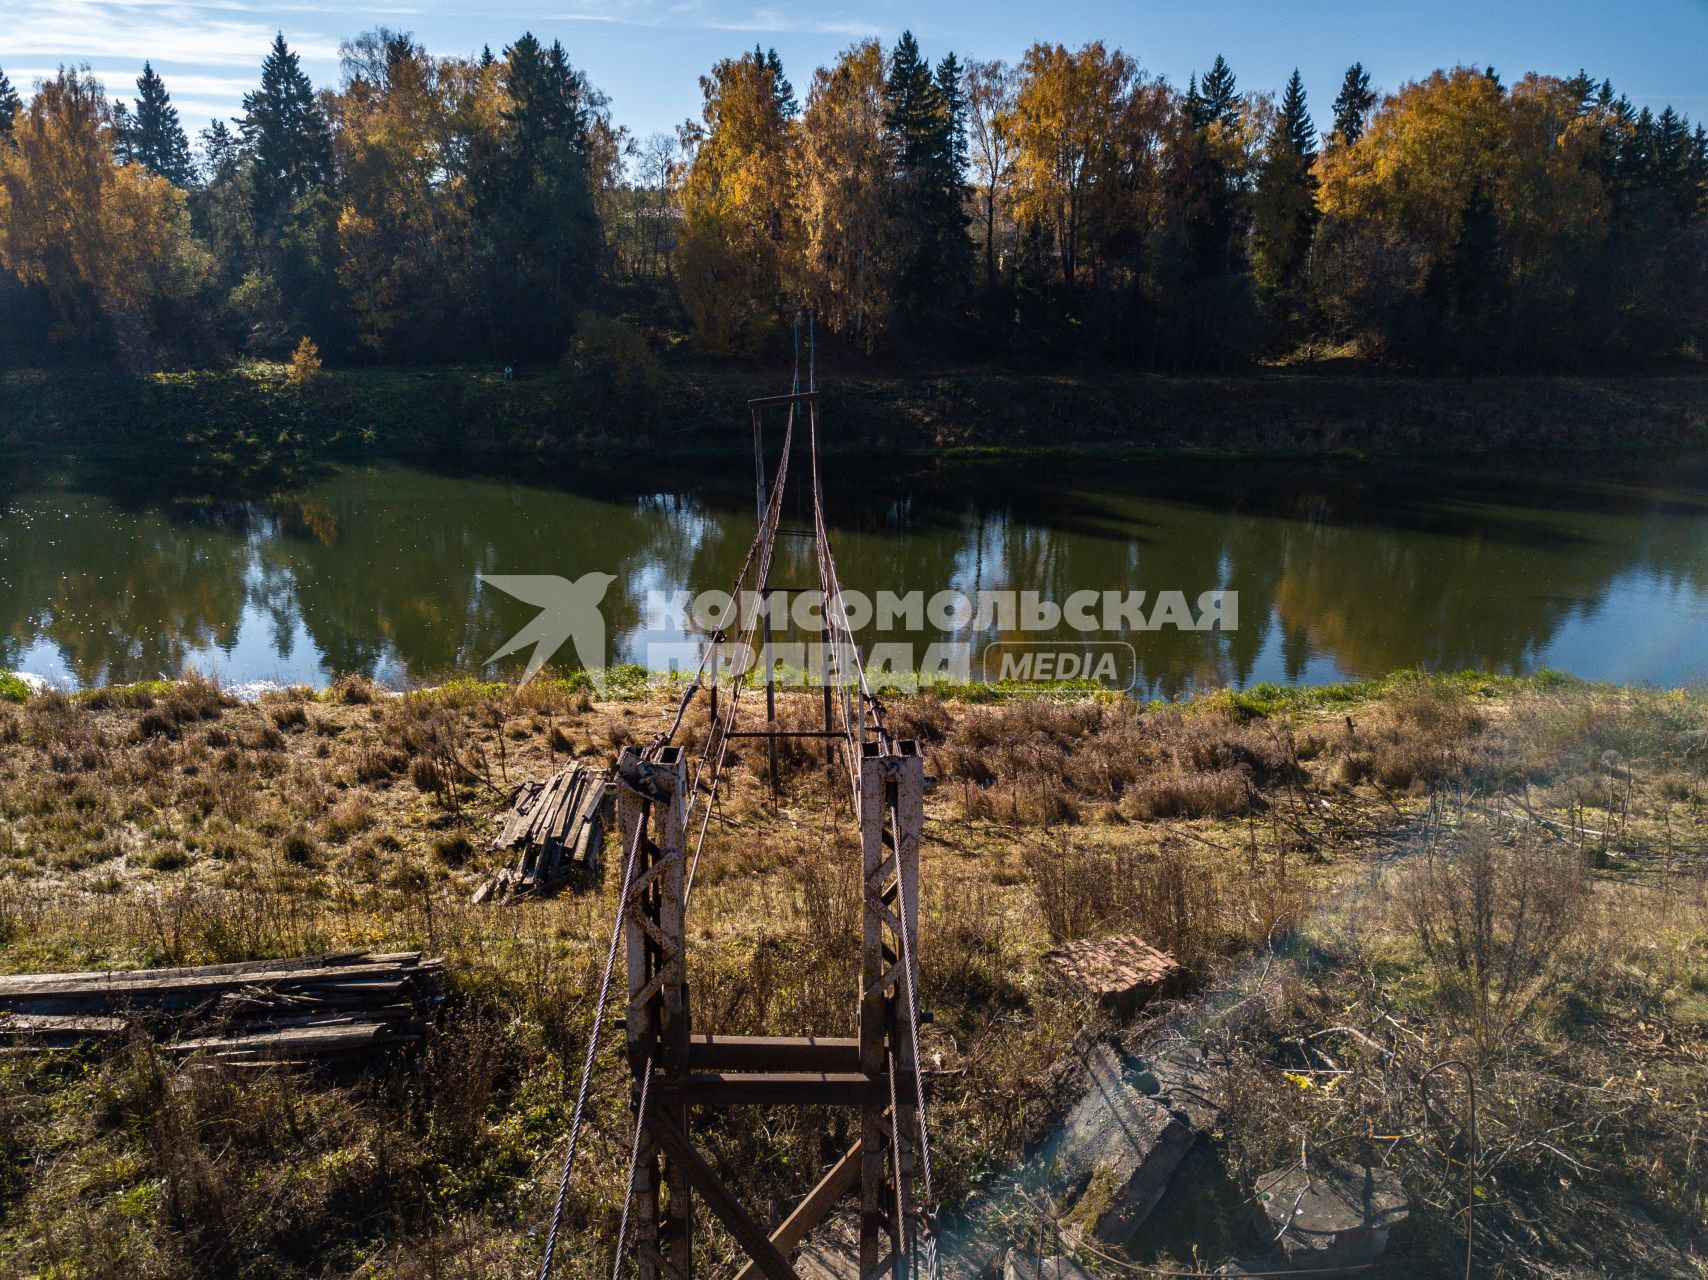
0, 675, 1708, 1278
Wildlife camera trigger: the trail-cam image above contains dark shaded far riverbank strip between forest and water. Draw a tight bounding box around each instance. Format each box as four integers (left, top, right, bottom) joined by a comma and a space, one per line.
0, 364, 1708, 468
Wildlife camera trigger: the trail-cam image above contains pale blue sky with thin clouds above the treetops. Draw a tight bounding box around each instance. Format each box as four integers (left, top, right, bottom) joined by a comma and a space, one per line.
0, 0, 1708, 151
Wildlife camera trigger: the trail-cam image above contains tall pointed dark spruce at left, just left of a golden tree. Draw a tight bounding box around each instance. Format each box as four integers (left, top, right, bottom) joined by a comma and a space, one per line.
241, 32, 331, 227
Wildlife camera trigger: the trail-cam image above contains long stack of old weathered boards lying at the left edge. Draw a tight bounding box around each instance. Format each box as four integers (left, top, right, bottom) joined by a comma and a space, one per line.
0, 952, 442, 1065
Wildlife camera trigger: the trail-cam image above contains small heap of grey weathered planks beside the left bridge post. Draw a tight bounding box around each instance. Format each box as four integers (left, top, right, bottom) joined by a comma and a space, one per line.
475, 764, 611, 902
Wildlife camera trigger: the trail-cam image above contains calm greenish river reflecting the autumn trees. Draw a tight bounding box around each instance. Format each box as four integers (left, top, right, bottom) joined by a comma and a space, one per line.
0, 455, 1708, 697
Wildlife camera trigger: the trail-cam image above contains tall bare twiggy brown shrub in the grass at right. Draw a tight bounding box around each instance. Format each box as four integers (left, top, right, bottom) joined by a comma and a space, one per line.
1404, 825, 1588, 1044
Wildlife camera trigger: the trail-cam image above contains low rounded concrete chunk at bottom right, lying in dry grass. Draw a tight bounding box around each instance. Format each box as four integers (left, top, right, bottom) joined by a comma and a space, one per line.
1257, 1166, 1409, 1266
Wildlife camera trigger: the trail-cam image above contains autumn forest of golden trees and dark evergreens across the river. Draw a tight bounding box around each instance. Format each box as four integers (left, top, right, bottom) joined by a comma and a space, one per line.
0, 29, 1708, 376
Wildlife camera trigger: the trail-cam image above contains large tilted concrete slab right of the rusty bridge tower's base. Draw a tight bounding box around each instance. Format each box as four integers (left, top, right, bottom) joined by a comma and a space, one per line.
1044, 1044, 1192, 1244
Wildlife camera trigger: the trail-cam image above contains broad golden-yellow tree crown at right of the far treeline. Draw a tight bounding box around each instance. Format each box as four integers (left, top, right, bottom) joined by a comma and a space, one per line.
1315, 67, 1653, 366
